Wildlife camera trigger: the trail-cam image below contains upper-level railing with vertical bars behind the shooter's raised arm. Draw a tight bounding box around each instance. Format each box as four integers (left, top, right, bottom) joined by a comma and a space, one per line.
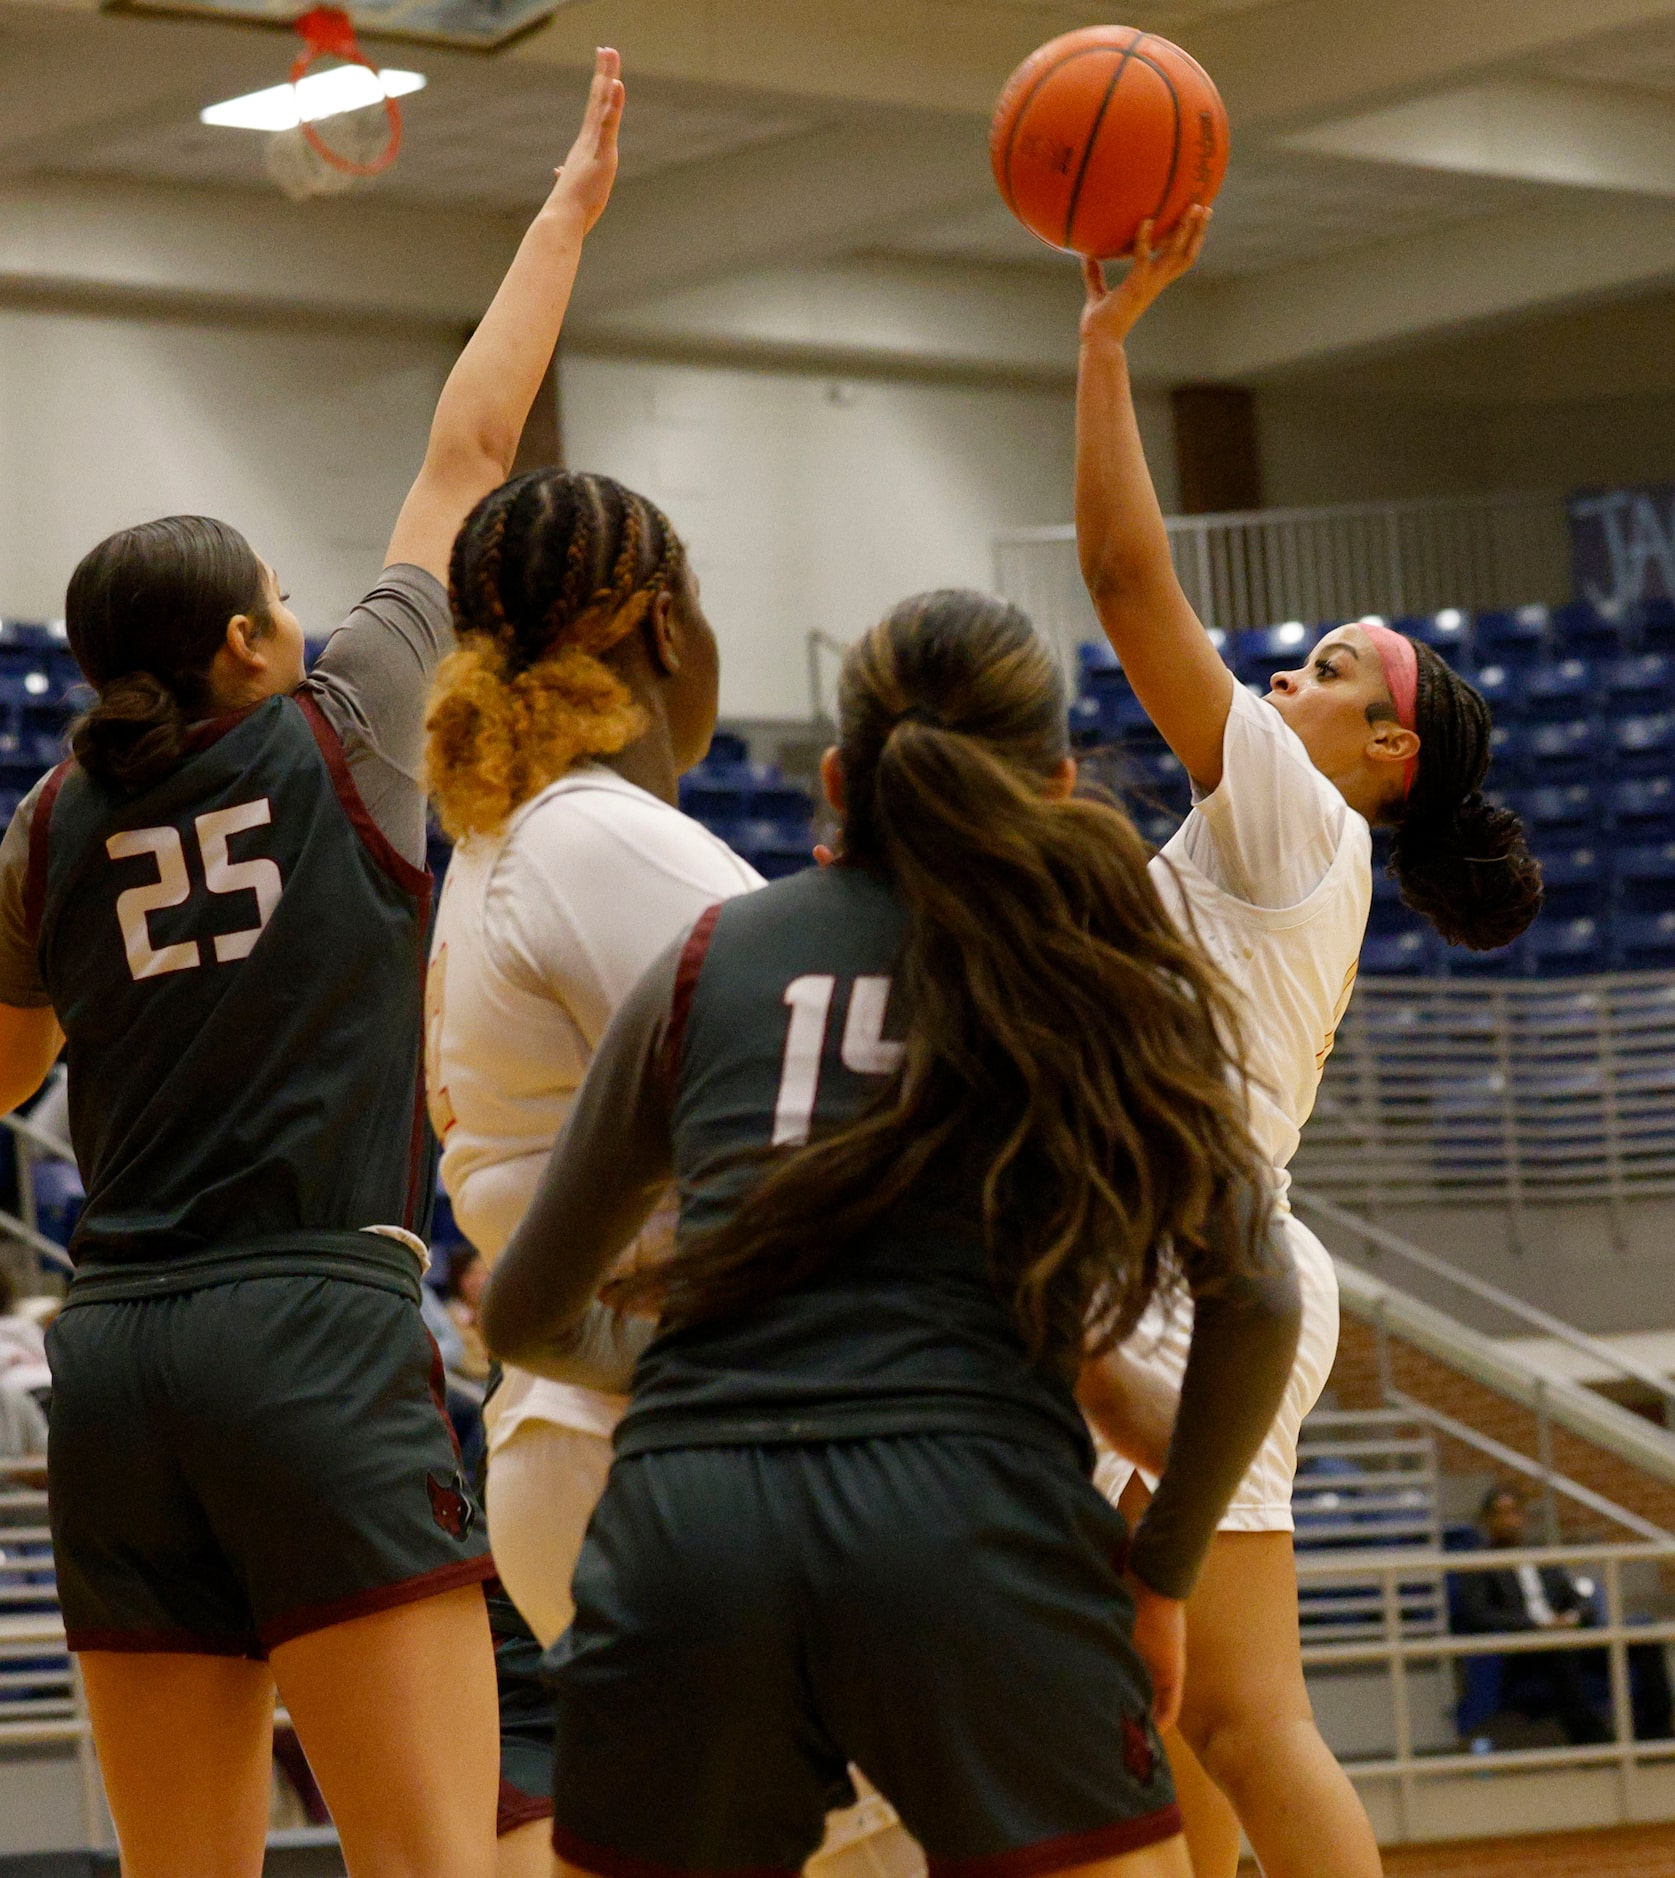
993, 490, 1570, 663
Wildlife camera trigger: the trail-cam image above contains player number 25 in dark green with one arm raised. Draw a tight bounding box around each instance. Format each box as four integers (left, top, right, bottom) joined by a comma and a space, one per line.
0, 53, 622, 1878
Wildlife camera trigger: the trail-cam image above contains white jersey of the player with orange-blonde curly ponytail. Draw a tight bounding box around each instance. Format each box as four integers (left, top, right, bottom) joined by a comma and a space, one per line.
426, 764, 762, 1452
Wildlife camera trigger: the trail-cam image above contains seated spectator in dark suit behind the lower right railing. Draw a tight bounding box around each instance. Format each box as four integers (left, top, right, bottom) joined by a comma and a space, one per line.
1453, 1487, 1614, 1745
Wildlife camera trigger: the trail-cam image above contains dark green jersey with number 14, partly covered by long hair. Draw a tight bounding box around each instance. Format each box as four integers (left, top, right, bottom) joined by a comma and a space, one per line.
618, 868, 1087, 1457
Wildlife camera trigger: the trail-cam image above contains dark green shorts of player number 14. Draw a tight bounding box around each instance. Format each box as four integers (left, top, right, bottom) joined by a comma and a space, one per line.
548, 1435, 1179, 1878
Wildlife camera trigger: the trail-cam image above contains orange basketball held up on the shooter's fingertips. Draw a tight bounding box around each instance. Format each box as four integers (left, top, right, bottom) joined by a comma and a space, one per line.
990, 26, 1228, 259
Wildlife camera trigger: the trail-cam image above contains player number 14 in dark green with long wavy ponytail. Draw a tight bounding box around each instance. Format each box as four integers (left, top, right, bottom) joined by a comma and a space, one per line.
484, 593, 1298, 1878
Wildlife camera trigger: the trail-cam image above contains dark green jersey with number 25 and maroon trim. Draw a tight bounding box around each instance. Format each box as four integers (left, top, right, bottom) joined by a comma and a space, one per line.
28, 693, 430, 1270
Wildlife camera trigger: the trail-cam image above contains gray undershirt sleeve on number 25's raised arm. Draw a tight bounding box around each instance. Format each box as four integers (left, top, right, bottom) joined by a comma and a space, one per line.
302, 565, 454, 868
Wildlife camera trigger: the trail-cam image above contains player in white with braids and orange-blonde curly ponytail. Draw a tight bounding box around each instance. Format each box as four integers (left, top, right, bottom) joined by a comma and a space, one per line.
426, 470, 762, 1878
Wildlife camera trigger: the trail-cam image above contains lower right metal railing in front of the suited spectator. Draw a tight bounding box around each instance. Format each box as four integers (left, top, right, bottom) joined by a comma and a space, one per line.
1298, 1540, 1675, 1839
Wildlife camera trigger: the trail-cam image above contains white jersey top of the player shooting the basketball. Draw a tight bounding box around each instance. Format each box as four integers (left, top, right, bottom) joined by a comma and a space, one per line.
1151, 685, 1373, 1193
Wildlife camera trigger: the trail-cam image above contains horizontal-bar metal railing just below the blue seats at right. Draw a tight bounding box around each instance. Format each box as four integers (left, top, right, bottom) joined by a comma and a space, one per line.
1294, 973, 1675, 1226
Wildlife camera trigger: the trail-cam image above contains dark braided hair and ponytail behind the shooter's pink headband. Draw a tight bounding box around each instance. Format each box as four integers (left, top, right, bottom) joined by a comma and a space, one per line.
1390, 642, 1542, 952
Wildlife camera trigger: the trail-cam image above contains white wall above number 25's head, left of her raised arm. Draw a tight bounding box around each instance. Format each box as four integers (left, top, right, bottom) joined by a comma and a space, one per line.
0, 306, 454, 633
